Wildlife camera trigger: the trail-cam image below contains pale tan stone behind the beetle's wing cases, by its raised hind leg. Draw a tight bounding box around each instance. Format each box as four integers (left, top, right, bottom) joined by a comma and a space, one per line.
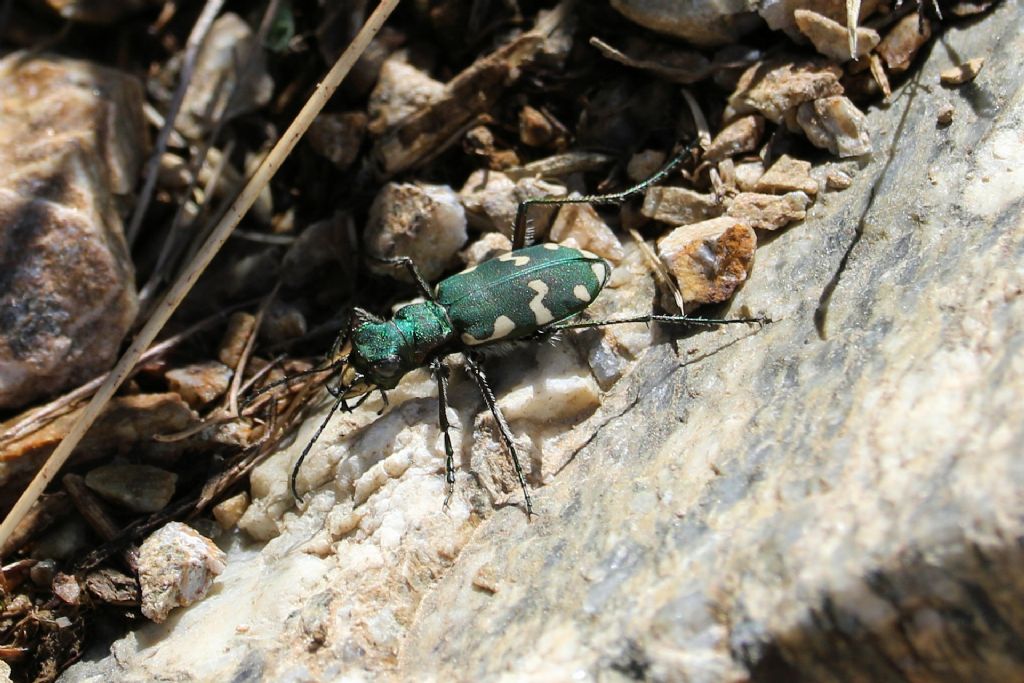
459, 169, 568, 239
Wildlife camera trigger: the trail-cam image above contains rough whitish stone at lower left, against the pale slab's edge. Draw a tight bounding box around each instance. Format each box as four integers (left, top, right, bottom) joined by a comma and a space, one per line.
138, 522, 227, 624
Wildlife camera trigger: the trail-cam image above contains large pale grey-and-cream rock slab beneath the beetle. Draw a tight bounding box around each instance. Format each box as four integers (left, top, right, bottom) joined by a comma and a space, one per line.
63, 3, 1024, 681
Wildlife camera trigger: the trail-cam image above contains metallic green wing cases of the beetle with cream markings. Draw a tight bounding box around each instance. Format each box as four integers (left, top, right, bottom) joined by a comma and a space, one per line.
437, 244, 611, 346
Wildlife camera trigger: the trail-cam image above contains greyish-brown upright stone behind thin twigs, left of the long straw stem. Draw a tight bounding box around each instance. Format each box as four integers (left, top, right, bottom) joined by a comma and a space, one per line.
174, 12, 273, 139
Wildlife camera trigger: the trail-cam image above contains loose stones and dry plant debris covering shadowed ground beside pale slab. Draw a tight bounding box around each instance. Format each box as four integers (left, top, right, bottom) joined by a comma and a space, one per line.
0, 0, 992, 681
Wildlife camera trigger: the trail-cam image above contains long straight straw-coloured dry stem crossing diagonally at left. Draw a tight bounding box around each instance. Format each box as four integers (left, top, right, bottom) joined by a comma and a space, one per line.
0, 0, 398, 557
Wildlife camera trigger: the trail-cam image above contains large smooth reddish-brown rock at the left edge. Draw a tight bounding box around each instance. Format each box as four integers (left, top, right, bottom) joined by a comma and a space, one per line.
0, 53, 144, 408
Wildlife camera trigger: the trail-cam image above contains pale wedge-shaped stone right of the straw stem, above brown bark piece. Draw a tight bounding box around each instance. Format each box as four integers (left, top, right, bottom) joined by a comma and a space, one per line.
367, 52, 444, 135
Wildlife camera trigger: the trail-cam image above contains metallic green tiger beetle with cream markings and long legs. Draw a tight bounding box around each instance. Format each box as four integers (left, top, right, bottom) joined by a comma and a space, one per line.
264, 143, 767, 515
